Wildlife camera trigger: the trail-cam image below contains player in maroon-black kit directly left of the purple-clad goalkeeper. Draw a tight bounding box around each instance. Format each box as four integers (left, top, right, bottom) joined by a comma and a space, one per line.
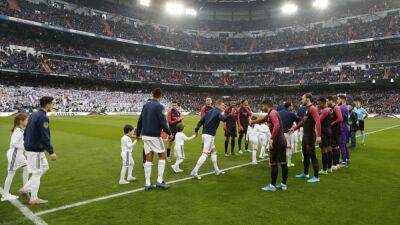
328, 96, 343, 170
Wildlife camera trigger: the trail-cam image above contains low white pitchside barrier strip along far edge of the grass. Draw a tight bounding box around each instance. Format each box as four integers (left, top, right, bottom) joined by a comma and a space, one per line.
0, 111, 400, 119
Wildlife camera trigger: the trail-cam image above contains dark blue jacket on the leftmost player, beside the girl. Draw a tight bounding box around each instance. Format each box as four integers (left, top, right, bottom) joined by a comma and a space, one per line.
24, 109, 54, 154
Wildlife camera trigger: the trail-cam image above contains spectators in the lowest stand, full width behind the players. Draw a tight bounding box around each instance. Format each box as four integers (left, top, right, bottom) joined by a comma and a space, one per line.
0, 85, 400, 115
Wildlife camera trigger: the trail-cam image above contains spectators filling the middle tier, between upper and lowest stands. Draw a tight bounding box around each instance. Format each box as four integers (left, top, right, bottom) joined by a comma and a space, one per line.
0, 46, 400, 87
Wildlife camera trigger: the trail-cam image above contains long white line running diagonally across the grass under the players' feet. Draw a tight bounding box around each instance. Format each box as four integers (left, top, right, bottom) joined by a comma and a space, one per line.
35, 125, 400, 216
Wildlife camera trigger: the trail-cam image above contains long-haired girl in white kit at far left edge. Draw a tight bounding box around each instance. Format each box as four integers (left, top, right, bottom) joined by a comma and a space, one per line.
1, 113, 29, 201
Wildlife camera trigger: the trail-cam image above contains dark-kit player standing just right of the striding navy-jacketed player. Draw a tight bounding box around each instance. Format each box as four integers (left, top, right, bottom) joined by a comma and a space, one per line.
224, 100, 237, 156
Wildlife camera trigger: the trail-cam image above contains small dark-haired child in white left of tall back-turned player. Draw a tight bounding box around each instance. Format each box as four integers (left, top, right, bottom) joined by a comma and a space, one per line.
119, 124, 137, 184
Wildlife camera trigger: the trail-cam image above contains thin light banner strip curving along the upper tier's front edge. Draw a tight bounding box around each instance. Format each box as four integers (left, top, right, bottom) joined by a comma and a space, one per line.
0, 15, 400, 56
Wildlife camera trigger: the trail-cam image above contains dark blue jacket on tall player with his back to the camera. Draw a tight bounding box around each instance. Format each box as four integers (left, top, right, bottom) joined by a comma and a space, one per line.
137, 99, 171, 137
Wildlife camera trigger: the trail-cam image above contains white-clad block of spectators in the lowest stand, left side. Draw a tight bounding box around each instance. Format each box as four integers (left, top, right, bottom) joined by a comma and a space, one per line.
0, 85, 169, 112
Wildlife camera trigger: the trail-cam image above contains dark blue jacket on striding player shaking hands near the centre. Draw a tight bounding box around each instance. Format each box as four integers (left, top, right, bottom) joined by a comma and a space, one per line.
195, 108, 228, 136
